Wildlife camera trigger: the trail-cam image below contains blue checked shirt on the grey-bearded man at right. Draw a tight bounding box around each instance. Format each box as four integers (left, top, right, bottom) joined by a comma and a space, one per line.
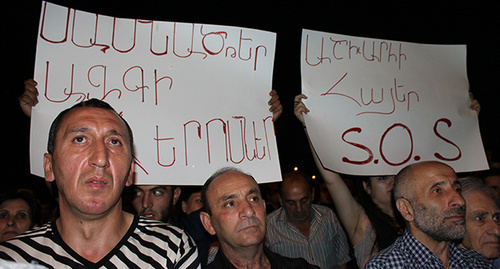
365, 228, 493, 269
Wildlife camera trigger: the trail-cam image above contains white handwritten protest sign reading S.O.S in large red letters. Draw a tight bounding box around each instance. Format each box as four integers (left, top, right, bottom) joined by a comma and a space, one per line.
301, 30, 488, 175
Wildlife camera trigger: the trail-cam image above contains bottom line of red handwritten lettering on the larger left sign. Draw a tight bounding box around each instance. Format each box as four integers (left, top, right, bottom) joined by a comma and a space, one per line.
154, 116, 277, 167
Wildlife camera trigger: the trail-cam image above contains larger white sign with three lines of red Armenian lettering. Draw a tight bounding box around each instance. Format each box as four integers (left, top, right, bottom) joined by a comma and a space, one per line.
31, 2, 281, 185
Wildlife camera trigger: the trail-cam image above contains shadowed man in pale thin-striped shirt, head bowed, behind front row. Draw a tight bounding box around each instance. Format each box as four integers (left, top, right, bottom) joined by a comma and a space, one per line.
266, 172, 351, 269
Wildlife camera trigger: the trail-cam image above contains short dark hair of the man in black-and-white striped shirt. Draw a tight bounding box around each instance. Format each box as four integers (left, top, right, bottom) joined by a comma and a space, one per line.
47, 98, 134, 154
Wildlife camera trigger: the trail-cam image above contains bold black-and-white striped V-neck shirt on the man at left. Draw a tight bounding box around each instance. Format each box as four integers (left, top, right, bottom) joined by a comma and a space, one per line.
0, 216, 200, 268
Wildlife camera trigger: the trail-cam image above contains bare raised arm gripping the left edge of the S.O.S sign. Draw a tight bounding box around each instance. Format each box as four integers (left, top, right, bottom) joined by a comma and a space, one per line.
294, 94, 369, 246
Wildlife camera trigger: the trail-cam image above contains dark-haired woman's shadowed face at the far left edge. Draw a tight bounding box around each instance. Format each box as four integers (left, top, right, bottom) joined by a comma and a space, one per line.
0, 191, 39, 242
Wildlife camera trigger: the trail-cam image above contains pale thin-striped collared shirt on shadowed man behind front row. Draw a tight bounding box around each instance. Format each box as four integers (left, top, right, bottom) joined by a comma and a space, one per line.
266, 204, 351, 269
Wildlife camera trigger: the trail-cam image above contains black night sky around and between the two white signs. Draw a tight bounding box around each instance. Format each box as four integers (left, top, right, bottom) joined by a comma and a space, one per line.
0, 0, 500, 199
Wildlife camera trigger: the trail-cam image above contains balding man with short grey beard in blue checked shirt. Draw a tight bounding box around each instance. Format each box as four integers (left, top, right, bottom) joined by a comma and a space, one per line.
365, 161, 492, 269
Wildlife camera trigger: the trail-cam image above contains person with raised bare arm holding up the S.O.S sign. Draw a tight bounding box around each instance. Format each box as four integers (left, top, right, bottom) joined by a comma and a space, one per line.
294, 94, 479, 268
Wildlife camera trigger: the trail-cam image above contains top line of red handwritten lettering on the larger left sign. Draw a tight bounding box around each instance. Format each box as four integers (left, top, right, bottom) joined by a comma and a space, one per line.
40, 2, 268, 71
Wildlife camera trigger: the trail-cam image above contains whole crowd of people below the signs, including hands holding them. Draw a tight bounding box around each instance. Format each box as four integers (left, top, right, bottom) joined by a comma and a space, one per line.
0, 79, 500, 268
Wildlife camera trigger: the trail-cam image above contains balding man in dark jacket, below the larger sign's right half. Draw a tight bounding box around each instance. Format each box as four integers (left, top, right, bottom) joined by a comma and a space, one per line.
200, 167, 317, 268
